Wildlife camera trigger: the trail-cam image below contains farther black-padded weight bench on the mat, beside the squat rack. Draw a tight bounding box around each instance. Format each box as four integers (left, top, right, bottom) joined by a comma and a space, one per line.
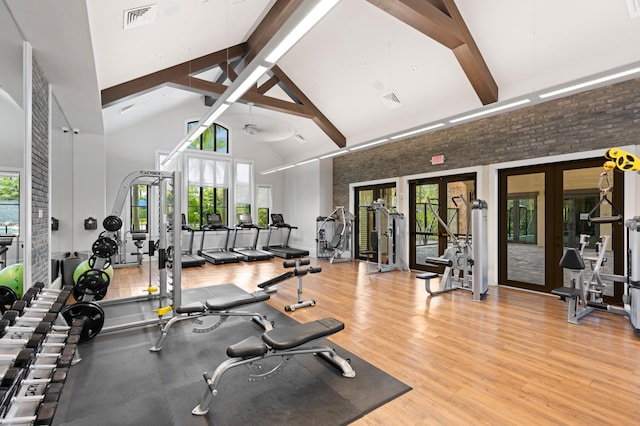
149, 291, 273, 352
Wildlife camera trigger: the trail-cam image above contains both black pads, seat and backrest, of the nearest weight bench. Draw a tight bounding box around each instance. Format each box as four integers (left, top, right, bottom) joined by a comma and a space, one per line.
227, 318, 344, 358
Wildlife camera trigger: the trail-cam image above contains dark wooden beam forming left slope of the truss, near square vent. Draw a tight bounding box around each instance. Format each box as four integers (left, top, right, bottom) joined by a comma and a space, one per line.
100, 43, 247, 108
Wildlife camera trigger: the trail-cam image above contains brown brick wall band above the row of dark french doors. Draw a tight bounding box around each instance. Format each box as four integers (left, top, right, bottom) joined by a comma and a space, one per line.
333, 78, 640, 206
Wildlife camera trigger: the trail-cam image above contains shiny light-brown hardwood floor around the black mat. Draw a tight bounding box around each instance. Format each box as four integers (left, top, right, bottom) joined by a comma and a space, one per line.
108, 259, 640, 425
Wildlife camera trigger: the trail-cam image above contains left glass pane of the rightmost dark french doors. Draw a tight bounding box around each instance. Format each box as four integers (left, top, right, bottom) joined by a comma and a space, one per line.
505, 173, 545, 286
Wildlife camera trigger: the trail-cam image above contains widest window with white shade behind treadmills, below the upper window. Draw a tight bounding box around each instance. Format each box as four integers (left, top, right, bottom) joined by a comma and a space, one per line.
187, 157, 229, 229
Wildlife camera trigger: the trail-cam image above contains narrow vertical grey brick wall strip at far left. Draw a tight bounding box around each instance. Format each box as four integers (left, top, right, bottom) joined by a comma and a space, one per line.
31, 57, 50, 283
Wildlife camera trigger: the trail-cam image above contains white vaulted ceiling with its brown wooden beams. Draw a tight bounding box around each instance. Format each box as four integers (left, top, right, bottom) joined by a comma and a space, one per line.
5, 0, 640, 165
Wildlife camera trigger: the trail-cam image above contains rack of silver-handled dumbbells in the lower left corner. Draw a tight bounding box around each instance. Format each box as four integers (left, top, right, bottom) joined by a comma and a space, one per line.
0, 283, 85, 425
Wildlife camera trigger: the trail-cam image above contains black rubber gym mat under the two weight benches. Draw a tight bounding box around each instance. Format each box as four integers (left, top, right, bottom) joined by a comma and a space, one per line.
53, 284, 411, 426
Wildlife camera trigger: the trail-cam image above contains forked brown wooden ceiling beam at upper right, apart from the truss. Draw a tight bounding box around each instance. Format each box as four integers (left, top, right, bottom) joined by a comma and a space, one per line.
367, 0, 498, 105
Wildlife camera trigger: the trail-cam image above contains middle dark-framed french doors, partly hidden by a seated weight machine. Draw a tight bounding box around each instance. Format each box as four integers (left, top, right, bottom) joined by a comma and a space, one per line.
408, 173, 476, 273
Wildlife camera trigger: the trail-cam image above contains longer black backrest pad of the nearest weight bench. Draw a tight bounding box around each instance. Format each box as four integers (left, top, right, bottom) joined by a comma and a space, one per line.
262, 318, 344, 350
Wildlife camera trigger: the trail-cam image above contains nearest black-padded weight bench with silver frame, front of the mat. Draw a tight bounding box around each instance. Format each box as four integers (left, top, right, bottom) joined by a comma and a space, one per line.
191, 318, 356, 416
